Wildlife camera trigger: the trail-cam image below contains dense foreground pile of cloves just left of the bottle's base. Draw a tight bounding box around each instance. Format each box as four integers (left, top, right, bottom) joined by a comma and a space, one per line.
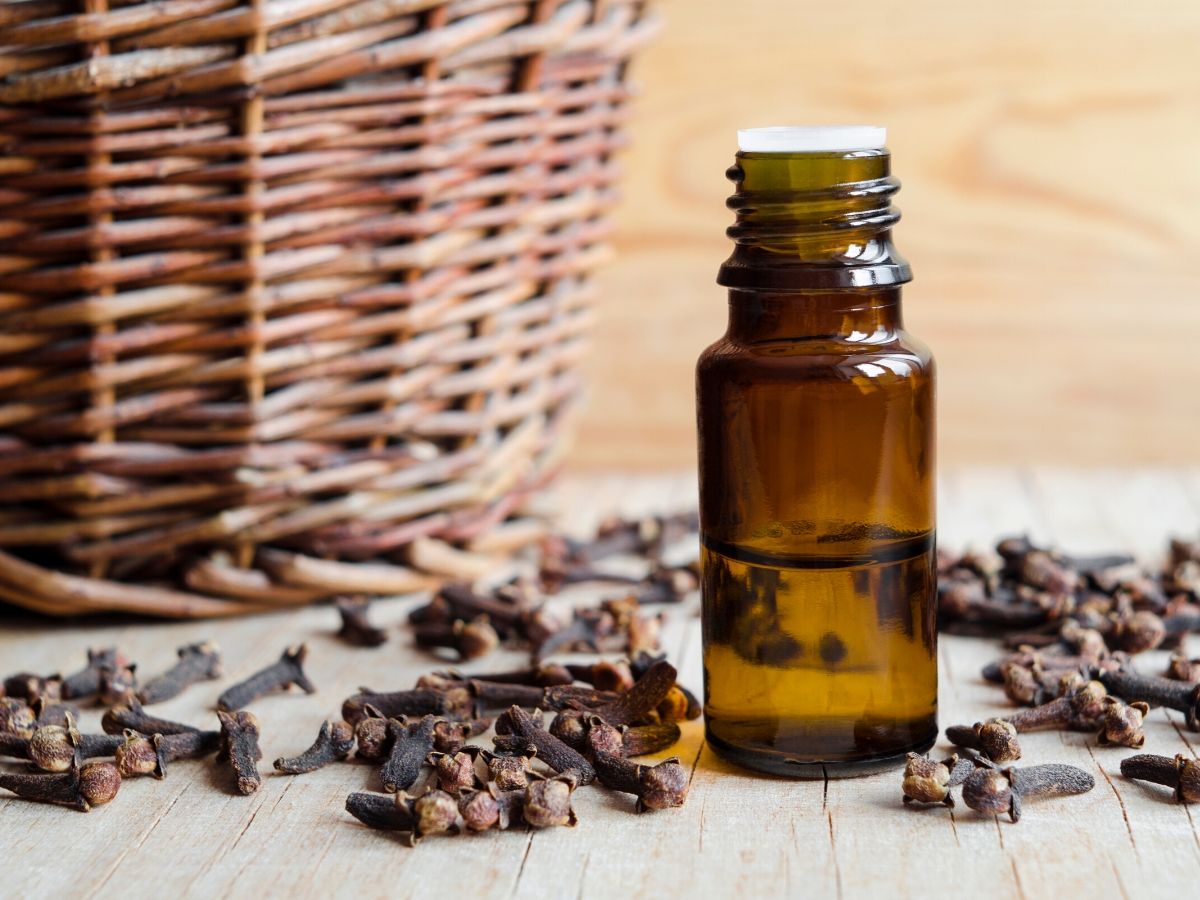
340, 652, 700, 844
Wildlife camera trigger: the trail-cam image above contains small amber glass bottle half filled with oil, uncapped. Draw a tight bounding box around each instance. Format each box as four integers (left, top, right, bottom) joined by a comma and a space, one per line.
696, 126, 937, 778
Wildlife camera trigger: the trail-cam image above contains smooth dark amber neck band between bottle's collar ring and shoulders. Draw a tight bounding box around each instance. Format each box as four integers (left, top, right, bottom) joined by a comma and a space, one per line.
727, 287, 904, 344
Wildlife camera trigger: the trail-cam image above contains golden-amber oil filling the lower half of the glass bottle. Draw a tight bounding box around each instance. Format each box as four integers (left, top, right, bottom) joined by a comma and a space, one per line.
702, 526, 937, 778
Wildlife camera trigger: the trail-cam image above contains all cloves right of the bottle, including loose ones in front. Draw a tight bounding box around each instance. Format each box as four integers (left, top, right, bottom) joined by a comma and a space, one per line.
904, 538, 1200, 821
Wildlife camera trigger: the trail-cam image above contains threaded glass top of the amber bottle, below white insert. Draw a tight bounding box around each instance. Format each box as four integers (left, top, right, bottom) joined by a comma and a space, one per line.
716, 150, 912, 290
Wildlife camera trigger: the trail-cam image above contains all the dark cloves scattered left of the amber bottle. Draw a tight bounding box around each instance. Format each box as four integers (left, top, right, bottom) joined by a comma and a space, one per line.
0, 516, 701, 844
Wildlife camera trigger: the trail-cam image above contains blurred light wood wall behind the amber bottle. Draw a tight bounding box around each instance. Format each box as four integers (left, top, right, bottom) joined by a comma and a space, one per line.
575, 0, 1200, 468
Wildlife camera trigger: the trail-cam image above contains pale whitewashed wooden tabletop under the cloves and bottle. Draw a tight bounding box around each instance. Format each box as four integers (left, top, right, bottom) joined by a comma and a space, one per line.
0, 470, 1200, 899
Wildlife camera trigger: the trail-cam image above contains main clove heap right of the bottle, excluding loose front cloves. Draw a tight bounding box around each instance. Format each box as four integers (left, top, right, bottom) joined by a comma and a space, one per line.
938, 538, 1200, 762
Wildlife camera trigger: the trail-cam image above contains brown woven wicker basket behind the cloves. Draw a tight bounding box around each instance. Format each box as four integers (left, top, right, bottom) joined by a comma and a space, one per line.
0, 0, 653, 617
